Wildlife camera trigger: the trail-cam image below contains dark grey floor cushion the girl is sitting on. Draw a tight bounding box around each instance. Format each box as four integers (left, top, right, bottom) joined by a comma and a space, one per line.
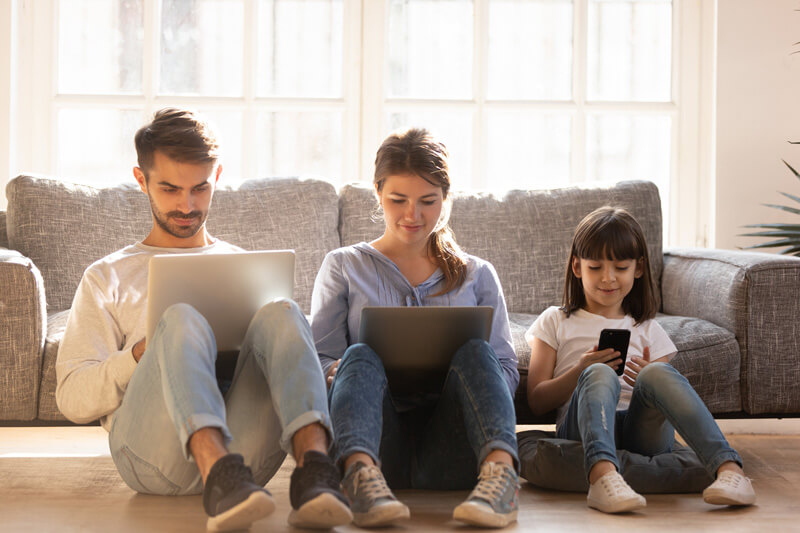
517, 430, 714, 494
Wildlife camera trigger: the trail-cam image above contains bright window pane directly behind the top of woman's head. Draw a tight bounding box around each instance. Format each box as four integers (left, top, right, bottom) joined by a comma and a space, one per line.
386, 111, 472, 190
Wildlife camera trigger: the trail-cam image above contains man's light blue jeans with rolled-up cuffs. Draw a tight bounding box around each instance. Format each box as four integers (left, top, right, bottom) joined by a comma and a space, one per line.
109, 300, 331, 495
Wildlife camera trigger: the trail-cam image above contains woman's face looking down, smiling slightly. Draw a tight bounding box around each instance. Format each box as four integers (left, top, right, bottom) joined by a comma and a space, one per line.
376, 174, 444, 250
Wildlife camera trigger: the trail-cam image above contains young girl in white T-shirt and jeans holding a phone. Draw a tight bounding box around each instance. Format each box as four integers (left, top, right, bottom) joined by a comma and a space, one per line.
525, 207, 755, 513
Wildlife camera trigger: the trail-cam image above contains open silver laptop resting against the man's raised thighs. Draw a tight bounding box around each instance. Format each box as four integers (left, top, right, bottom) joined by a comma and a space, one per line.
147, 250, 295, 352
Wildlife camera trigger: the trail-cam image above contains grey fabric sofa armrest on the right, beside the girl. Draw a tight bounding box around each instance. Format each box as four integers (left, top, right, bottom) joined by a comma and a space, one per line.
661, 248, 800, 414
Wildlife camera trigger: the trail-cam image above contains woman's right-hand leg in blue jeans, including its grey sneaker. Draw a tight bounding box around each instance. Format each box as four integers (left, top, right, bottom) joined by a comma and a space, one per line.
414, 340, 519, 527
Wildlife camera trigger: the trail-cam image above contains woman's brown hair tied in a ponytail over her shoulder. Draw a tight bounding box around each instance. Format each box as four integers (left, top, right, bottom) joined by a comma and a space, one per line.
373, 128, 467, 295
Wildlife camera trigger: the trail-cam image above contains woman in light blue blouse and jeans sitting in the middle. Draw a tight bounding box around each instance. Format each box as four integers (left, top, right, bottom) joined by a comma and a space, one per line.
311, 129, 519, 527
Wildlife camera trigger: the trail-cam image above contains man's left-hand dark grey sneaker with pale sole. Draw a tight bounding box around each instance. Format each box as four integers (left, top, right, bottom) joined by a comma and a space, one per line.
203, 453, 275, 531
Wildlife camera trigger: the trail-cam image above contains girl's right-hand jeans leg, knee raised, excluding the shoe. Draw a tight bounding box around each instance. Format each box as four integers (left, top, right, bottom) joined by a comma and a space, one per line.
622, 363, 742, 477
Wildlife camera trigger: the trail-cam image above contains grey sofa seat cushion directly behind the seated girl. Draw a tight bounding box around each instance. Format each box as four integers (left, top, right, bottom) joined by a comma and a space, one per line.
509, 313, 742, 424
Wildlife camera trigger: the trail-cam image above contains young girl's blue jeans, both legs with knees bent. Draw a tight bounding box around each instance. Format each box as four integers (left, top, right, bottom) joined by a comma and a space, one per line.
557, 363, 742, 478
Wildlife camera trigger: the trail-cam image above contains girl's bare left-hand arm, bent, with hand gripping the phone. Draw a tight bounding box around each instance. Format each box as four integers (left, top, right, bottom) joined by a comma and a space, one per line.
527, 337, 621, 415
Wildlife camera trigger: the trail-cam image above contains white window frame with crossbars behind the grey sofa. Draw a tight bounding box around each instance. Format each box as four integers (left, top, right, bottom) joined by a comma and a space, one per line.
7, 0, 716, 246
